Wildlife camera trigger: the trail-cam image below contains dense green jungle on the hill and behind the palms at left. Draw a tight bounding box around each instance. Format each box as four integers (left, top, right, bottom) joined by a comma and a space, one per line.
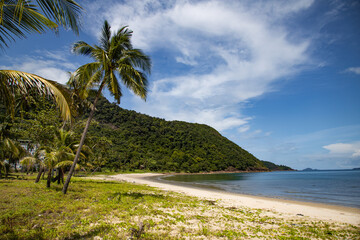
3, 93, 292, 173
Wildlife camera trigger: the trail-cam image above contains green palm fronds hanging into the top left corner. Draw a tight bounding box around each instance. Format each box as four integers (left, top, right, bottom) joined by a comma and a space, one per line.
0, 0, 82, 48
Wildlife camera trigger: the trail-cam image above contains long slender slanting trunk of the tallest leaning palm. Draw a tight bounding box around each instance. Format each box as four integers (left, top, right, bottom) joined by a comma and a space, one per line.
62, 80, 105, 194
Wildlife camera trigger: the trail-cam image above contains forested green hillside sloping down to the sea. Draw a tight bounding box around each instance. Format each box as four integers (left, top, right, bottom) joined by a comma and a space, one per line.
80, 98, 267, 172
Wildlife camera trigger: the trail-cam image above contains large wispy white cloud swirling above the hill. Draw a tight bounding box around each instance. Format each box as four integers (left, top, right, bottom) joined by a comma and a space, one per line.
84, 0, 313, 131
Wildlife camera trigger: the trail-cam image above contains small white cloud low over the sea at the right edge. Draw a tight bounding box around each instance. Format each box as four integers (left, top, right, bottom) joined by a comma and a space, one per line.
323, 142, 360, 158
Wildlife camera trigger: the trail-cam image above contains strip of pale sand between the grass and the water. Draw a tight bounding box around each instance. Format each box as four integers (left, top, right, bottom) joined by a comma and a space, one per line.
88, 173, 360, 226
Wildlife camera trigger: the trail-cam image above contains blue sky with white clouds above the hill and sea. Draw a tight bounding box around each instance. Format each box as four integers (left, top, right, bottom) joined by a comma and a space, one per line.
0, 0, 360, 169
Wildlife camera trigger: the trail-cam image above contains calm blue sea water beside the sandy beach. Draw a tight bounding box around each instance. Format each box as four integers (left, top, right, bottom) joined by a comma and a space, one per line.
163, 170, 360, 208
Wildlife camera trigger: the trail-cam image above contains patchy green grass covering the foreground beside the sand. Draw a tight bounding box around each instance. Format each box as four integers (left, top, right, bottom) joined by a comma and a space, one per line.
0, 177, 360, 239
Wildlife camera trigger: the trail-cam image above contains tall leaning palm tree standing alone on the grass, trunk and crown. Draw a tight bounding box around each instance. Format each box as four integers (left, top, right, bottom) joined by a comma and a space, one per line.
63, 21, 151, 194
